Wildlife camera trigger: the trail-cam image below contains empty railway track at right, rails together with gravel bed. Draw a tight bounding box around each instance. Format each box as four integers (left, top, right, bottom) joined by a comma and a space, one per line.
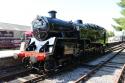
74, 45, 125, 83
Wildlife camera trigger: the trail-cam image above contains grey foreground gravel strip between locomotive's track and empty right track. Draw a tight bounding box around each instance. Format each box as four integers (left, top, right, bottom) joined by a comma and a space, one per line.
39, 68, 90, 83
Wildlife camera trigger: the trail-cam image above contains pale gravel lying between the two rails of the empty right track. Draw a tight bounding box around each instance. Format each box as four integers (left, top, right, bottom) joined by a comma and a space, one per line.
86, 50, 125, 83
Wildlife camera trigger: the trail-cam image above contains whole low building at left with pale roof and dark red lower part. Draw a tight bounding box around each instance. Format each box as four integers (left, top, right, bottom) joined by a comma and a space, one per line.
0, 22, 31, 49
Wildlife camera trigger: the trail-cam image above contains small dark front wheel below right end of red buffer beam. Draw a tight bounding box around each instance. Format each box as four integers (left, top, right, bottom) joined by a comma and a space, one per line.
44, 58, 56, 72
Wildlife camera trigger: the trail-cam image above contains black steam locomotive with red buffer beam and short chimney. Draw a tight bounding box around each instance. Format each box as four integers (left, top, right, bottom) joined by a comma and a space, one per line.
13, 11, 107, 72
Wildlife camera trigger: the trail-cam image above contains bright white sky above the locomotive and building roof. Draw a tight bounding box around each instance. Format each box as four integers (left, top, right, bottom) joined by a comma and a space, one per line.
0, 0, 121, 31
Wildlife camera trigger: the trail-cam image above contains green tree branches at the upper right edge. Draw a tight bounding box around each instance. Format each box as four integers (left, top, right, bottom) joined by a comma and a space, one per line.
112, 0, 125, 31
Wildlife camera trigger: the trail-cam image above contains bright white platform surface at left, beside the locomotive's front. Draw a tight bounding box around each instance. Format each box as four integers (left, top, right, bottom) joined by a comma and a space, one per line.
0, 50, 20, 58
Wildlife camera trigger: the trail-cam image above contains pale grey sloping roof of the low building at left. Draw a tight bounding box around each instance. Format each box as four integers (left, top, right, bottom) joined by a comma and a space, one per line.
0, 22, 31, 31
